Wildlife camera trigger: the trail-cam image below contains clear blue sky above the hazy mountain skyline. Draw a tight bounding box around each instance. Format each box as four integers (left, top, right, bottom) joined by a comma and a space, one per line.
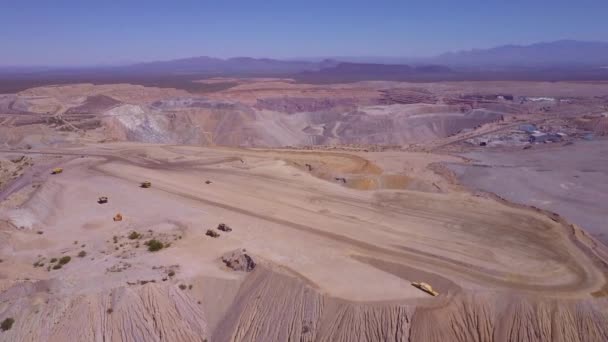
0, 0, 608, 65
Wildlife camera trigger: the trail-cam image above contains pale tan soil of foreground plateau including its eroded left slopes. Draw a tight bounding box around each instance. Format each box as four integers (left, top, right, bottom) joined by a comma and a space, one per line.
0, 143, 607, 340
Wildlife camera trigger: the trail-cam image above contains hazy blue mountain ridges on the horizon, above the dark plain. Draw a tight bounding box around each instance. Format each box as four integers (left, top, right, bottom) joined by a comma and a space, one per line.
117, 40, 608, 75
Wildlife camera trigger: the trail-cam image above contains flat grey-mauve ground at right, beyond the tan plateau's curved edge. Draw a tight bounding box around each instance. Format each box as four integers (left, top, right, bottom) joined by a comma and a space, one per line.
450, 139, 608, 245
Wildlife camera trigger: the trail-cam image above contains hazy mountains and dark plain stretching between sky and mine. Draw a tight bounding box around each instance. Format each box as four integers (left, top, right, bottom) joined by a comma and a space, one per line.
0, 40, 608, 93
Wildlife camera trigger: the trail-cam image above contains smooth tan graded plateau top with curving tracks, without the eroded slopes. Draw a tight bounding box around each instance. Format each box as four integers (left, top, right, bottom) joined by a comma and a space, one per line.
4, 144, 604, 301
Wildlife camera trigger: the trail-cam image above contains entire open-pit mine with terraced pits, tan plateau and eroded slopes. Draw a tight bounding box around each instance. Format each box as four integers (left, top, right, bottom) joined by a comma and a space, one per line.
0, 78, 608, 342
